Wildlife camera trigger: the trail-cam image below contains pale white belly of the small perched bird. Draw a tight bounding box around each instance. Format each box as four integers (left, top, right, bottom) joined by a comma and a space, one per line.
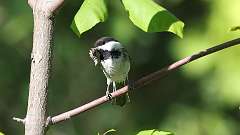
101, 59, 130, 82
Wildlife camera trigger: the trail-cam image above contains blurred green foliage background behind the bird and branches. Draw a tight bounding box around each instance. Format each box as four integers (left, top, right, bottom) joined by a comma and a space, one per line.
0, 0, 240, 135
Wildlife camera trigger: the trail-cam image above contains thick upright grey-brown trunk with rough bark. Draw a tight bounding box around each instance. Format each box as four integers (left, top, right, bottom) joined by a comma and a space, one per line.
25, 0, 63, 135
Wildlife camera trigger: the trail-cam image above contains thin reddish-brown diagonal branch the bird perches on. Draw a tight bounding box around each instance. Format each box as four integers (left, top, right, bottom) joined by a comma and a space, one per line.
47, 38, 240, 125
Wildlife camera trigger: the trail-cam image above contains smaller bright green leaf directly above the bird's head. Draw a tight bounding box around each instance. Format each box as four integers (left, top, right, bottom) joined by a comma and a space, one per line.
71, 0, 108, 36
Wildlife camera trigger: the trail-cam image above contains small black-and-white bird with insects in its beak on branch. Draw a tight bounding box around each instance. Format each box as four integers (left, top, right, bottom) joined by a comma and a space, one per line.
89, 37, 130, 106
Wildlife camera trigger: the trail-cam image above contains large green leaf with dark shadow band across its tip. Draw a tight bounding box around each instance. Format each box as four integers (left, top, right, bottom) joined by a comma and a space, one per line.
122, 0, 184, 38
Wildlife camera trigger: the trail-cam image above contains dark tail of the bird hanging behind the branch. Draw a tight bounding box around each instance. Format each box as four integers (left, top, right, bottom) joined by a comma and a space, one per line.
112, 82, 130, 106
